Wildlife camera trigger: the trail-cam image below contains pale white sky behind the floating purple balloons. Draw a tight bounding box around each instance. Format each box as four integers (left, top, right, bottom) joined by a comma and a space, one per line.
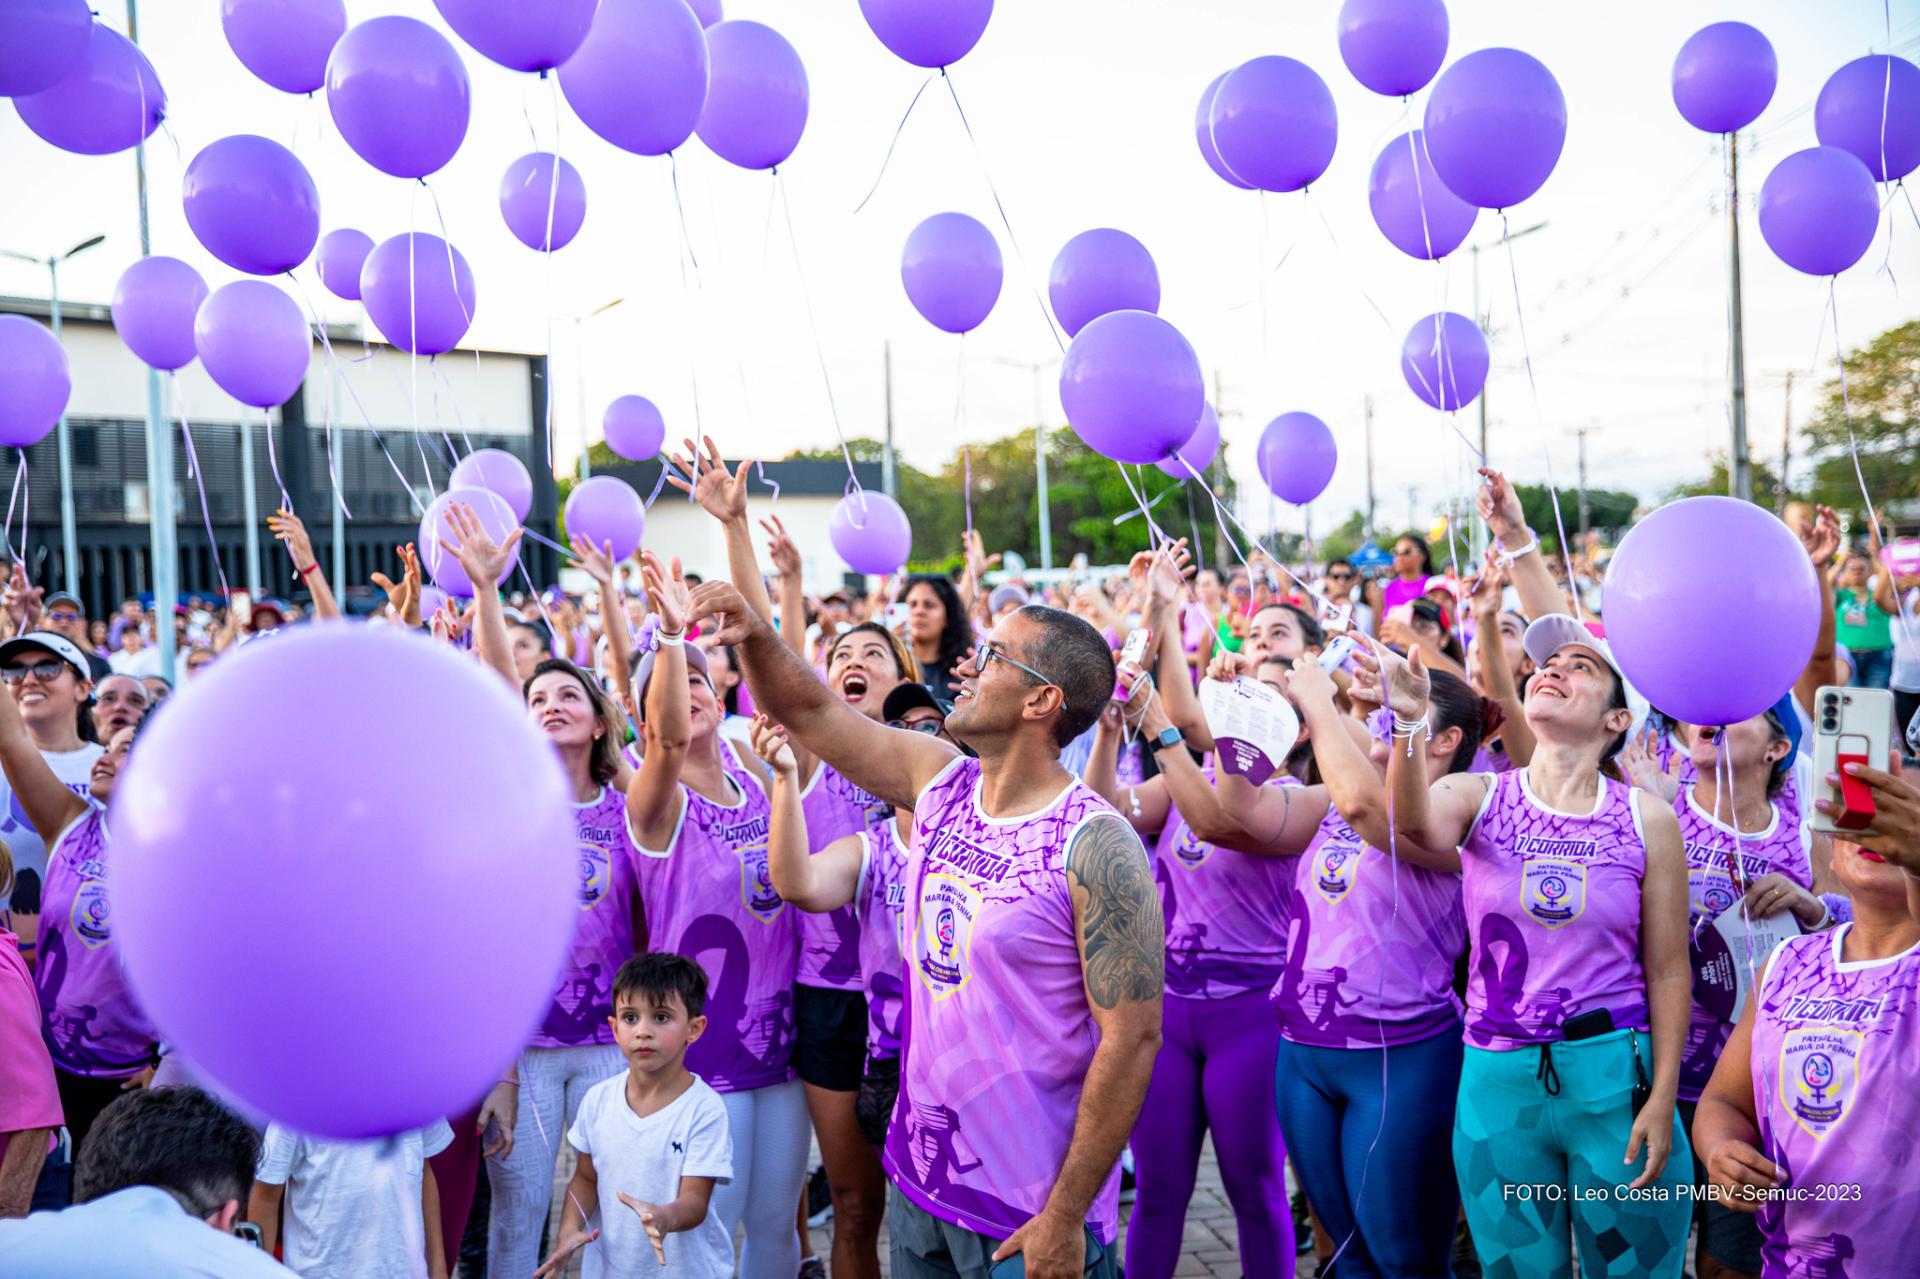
0, 0, 1920, 530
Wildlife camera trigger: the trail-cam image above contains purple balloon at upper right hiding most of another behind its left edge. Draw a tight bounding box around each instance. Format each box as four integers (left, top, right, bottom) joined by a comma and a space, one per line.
1212, 54, 1340, 192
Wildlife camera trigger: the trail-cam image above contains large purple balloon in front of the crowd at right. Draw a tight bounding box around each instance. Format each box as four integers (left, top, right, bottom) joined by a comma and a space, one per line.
1603, 497, 1820, 726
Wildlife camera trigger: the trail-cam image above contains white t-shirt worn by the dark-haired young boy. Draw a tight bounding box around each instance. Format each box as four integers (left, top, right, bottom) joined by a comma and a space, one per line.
566, 1072, 733, 1279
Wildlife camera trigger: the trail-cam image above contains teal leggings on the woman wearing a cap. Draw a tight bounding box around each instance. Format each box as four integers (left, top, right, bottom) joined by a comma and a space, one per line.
1453, 1031, 1693, 1279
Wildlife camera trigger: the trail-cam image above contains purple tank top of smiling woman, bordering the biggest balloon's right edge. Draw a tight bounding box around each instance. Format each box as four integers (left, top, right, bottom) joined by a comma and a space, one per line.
528, 785, 639, 1049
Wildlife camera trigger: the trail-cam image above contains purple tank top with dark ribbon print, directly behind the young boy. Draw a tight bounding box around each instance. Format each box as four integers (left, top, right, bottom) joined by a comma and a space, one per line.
634, 741, 799, 1093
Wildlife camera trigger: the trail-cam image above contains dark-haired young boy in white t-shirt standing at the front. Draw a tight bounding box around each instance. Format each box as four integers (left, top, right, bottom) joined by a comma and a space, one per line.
536, 954, 733, 1279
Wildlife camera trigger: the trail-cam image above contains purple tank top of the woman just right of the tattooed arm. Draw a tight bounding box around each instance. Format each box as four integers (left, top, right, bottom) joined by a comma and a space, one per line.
1154, 757, 1294, 999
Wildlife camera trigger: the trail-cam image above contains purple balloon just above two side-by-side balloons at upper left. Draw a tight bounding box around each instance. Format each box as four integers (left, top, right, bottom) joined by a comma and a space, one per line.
180, 133, 321, 275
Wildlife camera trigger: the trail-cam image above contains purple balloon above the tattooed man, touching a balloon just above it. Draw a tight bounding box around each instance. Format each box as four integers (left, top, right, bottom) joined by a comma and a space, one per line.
1060, 311, 1206, 465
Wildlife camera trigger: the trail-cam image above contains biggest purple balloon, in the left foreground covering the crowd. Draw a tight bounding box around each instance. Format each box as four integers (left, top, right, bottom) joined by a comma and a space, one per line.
113, 626, 580, 1141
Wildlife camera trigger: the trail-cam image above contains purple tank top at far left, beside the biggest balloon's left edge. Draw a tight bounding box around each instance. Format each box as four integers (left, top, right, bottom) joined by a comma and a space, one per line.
33, 803, 157, 1079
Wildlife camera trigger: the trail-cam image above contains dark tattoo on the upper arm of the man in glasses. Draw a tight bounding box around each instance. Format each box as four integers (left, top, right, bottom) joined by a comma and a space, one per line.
1068, 816, 1167, 1008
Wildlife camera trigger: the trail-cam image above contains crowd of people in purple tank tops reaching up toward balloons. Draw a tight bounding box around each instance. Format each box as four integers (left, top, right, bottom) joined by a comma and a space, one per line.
0, 442, 1920, 1279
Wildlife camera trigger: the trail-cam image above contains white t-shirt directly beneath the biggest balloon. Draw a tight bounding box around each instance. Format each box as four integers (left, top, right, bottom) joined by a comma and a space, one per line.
255, 1120, 453, 1279
